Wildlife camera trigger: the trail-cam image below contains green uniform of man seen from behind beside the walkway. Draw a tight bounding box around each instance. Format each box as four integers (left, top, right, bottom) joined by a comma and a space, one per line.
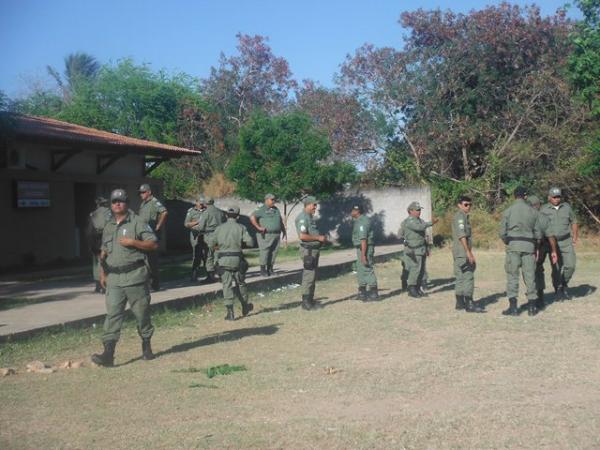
207, 216, 253, 306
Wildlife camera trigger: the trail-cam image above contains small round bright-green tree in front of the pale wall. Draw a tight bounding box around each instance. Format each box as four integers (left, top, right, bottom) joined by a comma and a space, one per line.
228, 112, 356, 227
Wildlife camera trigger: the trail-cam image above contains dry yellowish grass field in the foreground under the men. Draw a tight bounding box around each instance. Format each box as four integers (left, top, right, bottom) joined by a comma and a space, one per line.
0, 247, 600, 449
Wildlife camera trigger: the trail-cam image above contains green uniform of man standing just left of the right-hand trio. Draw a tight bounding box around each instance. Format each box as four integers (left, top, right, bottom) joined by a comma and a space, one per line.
452, 210, 475, 297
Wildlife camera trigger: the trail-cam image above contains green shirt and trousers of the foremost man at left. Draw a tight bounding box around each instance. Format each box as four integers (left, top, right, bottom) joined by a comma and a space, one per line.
102, 211, 156, 342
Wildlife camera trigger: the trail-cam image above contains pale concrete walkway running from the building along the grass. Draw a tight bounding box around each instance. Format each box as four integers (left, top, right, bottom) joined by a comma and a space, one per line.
0, 245, 403, 341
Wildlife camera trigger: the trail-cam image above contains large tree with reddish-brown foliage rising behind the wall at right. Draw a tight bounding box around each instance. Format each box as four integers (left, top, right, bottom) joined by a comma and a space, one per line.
340, 4, 571, 185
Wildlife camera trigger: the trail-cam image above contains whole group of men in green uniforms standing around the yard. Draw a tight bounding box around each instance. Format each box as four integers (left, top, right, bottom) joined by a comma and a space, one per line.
85, 185, 578, 366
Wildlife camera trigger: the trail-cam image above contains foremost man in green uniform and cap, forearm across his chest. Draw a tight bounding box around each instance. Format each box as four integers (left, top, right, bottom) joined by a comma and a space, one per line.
92, 189, 158, 367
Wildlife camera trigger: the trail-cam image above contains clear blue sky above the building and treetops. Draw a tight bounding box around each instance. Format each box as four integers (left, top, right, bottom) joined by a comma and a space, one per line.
0, 0, 574, 97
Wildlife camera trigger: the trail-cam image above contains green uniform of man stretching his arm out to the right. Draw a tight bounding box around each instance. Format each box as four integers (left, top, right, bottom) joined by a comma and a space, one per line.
400, 216, 433, 286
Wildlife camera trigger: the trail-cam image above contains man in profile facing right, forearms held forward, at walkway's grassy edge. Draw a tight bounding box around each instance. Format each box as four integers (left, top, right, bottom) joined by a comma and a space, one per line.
296, 195, 327, 310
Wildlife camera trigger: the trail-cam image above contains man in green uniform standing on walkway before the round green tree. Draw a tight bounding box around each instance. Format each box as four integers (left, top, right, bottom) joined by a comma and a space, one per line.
250, 194, 286, 276
